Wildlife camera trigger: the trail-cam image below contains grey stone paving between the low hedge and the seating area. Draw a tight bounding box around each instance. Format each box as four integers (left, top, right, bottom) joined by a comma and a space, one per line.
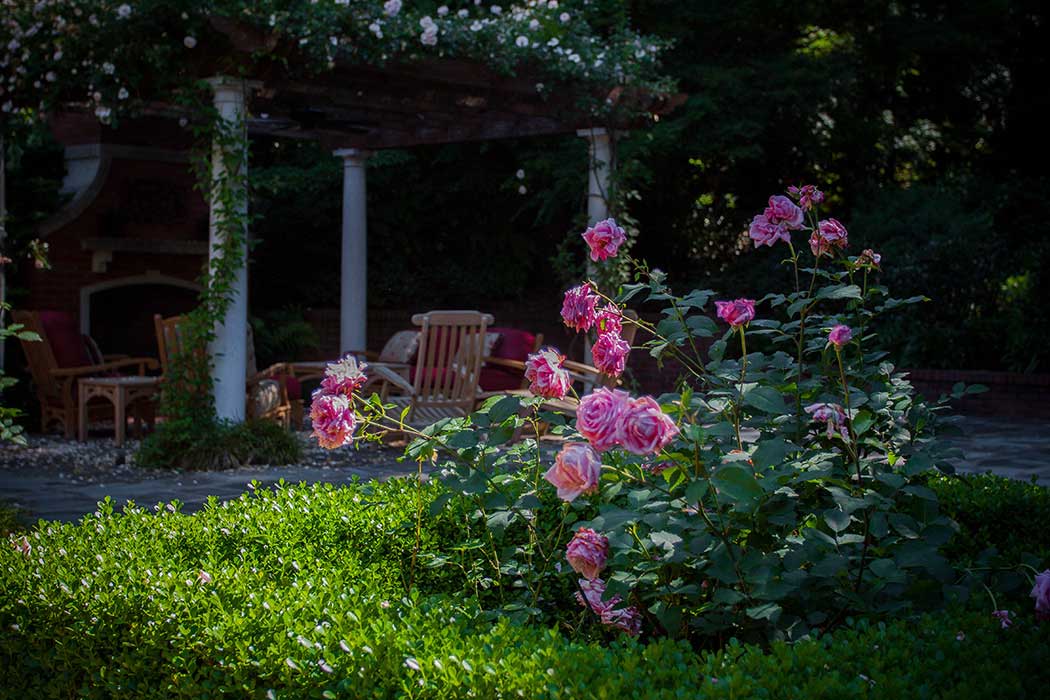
0, 417, 1050, 522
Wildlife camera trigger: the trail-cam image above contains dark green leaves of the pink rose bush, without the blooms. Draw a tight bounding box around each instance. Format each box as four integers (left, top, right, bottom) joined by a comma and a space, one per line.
408, 196, 960, 639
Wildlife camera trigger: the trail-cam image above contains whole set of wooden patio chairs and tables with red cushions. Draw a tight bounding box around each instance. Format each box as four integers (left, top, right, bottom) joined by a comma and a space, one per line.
14, 311, 633, 446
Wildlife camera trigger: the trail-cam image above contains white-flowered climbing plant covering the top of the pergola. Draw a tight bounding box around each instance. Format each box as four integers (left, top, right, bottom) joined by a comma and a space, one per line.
0, 0, 658, 126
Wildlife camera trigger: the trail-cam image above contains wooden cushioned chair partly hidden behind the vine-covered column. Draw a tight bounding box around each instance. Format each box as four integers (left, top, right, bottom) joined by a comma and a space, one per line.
153, 315, 302, 428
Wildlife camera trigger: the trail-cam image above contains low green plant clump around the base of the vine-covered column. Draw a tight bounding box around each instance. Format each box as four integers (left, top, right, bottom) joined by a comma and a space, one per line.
135, 419, 302, 469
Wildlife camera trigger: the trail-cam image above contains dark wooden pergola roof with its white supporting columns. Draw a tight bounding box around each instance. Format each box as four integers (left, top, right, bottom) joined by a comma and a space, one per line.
12, 18, 684, 421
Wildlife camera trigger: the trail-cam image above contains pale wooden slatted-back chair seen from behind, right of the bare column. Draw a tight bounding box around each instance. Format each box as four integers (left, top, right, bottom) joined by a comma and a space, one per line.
369, 311, 492, 427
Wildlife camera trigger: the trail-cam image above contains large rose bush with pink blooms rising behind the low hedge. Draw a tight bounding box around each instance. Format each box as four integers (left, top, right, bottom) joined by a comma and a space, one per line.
407, 185, 974, 639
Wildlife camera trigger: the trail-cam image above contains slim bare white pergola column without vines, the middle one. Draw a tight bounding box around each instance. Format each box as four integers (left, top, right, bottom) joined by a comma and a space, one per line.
335, 148, 370, 355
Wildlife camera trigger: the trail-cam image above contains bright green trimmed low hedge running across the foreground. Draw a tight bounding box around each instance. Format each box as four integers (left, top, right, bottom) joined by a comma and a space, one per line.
0, 474, 1050, 700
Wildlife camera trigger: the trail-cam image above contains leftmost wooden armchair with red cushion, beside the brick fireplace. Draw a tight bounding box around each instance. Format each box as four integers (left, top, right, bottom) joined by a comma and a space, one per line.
12, 311, 158, 439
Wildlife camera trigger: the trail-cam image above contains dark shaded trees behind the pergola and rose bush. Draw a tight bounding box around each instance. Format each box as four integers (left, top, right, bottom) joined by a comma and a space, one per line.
8, 0, 1050, 372
